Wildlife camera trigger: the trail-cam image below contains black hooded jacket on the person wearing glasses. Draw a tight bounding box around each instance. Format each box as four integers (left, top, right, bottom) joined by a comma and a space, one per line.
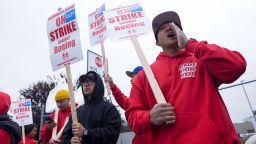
62, 72, 121, 144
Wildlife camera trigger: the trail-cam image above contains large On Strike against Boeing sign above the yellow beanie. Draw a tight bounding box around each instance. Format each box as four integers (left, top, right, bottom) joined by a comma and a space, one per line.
47, 5, 83, 71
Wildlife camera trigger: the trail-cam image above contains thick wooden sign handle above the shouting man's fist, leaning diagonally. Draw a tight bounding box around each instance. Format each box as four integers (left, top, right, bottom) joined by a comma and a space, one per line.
131, 36, 166, 103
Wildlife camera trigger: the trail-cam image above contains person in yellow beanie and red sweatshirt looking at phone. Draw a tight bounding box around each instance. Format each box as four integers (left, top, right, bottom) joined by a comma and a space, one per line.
41, 89, 71, 143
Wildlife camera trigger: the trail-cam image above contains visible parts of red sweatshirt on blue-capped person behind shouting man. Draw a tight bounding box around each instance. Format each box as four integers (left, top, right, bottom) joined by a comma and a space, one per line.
111, 85, 152, 144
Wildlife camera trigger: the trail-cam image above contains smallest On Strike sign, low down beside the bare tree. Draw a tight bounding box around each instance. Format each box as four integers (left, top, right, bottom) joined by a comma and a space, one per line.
12, 99, 33, 126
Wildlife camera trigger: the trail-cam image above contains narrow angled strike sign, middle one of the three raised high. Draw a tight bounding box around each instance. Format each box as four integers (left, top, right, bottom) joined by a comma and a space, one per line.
88, 4, 107, 47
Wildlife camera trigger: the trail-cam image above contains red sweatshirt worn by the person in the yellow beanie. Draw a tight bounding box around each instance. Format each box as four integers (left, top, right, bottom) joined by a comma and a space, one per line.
41, 107, 71, 143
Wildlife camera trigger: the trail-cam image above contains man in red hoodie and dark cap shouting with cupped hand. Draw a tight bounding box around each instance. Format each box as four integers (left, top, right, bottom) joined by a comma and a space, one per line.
125, 11, 246, 144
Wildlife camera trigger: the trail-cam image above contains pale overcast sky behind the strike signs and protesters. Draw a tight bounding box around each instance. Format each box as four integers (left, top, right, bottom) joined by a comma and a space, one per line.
0, 0, 256, 122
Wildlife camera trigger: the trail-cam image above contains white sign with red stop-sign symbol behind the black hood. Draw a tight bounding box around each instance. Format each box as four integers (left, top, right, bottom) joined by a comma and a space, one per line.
87, 50, 104, 76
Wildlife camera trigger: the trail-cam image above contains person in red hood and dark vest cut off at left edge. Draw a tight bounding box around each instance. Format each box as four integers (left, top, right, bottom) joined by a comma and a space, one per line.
0, 92, 21, 144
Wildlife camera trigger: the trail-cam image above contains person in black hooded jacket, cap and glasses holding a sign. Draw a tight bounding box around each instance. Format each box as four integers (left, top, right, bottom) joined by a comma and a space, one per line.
62, 71, 121, 144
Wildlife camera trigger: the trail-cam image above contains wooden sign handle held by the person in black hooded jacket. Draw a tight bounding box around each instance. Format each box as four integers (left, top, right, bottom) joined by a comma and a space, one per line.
66, 65, 77, 123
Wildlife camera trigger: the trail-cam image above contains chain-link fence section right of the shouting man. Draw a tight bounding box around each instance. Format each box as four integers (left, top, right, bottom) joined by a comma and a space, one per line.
219, 79, 256, 141
